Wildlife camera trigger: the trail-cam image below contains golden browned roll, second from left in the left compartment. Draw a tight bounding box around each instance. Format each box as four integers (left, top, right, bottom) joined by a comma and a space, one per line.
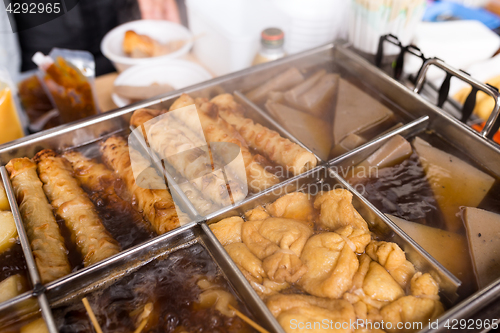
34, 149, 120, 266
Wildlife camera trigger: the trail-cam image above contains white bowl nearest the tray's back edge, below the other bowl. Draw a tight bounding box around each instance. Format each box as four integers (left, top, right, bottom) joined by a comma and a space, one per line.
111, 59, 212, 108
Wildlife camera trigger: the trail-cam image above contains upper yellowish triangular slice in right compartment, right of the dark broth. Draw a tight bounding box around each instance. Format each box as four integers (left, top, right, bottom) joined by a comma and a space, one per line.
413, 137, 495, 232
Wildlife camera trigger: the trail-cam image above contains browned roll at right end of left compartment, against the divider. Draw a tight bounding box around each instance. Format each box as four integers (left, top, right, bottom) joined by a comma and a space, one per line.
101, 136, 180, 234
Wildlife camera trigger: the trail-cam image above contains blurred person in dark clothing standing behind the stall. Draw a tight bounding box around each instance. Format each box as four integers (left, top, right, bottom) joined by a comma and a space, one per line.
14, 0, 185, 76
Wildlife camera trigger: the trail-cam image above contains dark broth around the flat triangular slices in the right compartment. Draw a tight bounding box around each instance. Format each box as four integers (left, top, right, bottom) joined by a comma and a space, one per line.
350, 132, 500, 296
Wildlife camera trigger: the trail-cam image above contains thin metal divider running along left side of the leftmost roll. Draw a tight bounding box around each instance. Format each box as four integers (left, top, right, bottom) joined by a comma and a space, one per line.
0, 166, 58, 333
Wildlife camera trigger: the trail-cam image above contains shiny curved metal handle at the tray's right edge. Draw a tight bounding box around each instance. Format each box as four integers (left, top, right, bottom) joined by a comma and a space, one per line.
413, 58, 500, 139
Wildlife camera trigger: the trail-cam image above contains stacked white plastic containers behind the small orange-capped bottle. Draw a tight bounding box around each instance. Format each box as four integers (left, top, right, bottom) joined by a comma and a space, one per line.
186, 0, 287, 75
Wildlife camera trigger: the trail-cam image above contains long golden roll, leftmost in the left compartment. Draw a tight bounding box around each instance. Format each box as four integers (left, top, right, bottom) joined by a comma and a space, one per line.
6, 157, 71, 283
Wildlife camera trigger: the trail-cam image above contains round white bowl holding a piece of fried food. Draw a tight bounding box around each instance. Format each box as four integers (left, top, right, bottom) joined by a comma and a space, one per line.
101, 20, 193, 72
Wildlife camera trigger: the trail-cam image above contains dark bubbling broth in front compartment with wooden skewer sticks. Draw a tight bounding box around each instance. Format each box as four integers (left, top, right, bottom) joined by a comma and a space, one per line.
55, 244, 258, 333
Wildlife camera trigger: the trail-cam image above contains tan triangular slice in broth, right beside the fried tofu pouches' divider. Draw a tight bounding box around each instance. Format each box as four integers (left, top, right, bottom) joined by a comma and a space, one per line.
388, 215, 472, 281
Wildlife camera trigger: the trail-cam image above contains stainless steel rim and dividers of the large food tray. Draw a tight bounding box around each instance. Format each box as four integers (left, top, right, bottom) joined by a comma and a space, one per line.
0, 44, 500, 333
